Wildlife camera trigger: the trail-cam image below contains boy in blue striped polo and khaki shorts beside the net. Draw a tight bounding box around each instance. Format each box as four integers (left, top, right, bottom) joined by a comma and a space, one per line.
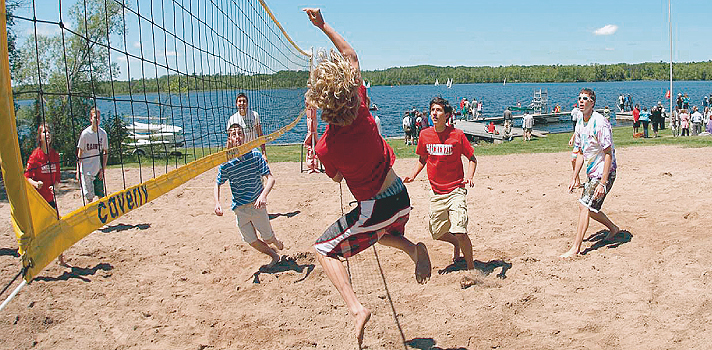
214, 124, 284, 267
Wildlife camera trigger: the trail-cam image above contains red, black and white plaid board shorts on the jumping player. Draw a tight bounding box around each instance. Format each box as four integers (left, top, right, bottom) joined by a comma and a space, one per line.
314, 178, 410, 259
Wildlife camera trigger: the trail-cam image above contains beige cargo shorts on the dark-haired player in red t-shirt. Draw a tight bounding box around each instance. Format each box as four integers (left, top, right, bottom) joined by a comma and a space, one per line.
428, 187, 468, 239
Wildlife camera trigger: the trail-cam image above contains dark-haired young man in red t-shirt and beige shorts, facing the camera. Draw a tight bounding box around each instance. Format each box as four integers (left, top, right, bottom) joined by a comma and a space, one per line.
403, 97, 477, 270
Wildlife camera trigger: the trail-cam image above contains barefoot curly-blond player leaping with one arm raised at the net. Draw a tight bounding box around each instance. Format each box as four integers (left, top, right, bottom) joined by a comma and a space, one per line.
304, 8, 431, 346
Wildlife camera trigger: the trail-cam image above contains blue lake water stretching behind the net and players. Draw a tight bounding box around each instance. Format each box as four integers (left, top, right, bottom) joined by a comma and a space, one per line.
13, 81, 712, 146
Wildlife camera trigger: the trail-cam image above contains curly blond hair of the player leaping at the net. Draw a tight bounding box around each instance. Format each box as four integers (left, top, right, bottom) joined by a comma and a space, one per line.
304, 49, 361, 126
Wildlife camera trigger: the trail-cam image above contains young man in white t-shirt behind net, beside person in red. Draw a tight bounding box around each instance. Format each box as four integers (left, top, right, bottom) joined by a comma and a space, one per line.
76, 107, 109, 202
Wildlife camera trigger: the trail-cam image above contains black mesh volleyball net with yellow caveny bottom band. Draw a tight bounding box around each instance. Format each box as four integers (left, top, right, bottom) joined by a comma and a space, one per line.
0, 0, 311, 281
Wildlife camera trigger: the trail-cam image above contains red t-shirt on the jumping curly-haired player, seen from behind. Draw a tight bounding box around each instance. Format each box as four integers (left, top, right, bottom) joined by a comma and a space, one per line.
315, 85, 396, 201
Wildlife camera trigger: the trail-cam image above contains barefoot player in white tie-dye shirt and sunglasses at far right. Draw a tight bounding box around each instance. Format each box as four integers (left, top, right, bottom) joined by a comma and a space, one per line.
561, 88, 620, 258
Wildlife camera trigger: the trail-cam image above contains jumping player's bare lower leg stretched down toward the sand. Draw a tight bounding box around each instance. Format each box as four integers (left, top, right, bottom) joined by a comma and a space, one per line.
316, 253, 371, 347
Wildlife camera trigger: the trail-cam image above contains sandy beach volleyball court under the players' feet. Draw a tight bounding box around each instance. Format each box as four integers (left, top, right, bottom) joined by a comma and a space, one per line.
0, 146, 712, 350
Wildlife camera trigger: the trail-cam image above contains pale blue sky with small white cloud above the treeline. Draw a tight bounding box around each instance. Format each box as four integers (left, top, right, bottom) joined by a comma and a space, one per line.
12, 0, 712, 79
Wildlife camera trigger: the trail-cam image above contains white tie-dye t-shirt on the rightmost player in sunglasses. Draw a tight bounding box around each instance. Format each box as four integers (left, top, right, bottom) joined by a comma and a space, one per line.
574, 112, 616, 179
